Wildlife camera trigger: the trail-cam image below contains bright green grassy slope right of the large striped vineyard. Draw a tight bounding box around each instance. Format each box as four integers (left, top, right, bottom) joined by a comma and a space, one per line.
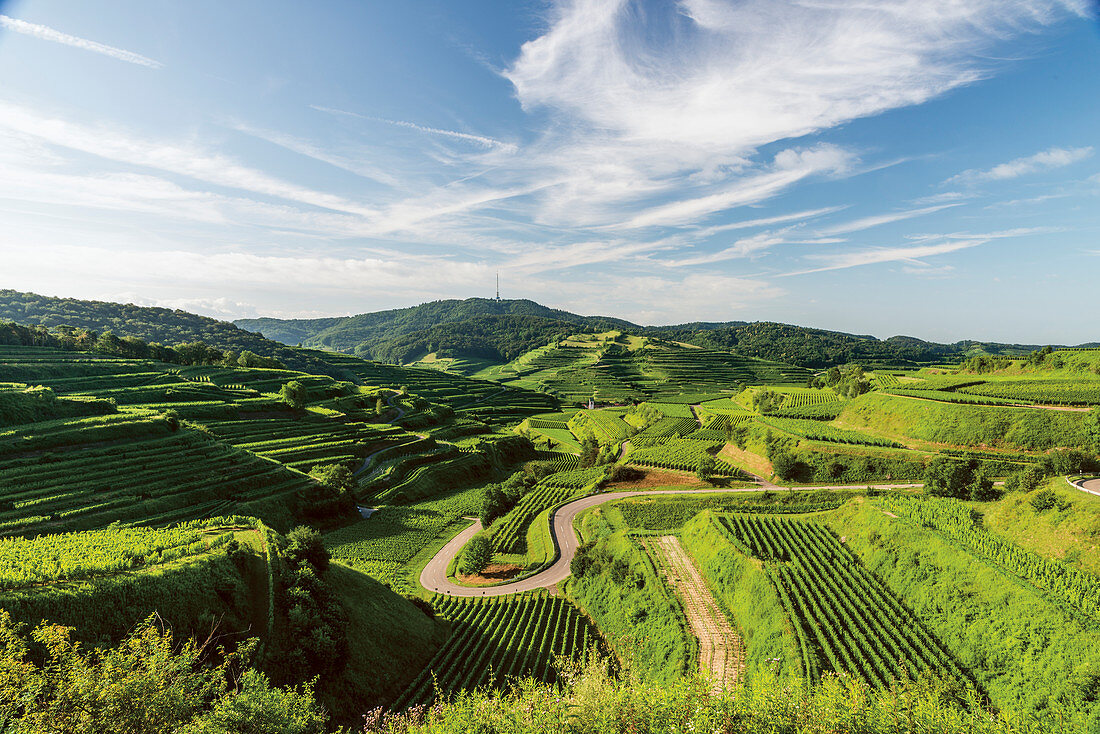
827, 500, 1100, 723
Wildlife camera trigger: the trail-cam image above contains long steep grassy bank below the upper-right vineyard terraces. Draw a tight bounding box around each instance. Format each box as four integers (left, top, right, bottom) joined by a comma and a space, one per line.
838, 393, 1085, 450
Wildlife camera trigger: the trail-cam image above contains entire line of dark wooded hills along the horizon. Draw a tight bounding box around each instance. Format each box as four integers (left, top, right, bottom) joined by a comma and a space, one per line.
0, 289, 1100, 374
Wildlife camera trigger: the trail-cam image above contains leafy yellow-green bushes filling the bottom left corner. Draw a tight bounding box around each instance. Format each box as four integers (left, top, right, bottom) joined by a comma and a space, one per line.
0, 610, 326, 734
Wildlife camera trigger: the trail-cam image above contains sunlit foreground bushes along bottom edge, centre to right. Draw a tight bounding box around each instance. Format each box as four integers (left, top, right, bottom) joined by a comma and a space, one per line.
363, 665, 1078, 734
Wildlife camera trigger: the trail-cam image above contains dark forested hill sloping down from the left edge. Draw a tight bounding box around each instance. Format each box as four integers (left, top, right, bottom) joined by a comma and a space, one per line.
0, 289, 332, 374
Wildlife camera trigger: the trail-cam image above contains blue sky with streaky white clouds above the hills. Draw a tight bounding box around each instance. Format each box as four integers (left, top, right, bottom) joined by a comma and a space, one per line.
0, 0, 1100, 343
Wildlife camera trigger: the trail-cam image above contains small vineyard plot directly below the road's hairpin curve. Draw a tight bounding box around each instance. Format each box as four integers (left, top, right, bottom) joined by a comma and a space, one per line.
391, 594, 598, 711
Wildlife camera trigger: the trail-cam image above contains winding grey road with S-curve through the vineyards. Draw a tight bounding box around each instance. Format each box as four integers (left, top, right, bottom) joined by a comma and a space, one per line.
420, 484, 924, 596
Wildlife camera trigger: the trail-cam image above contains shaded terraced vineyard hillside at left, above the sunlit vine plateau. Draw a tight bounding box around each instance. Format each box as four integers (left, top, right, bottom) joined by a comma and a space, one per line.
0, 414, 315, 535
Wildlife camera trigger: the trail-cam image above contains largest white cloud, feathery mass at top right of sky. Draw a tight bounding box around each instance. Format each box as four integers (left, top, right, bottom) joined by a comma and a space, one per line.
504, 0, 1086, 227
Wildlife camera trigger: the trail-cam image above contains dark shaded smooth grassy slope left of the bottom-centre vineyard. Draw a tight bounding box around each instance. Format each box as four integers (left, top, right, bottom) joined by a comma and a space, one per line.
320, 563, 447, 720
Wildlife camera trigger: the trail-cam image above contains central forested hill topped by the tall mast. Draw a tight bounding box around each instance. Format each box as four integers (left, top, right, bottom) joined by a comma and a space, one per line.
234, 298, 640, 362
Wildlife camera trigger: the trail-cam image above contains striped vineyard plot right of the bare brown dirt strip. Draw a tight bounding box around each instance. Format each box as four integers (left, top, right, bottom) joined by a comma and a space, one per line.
715, 514, 969, 688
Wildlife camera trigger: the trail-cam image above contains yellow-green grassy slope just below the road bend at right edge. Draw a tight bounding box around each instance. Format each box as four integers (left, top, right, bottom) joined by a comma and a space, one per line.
975, 476, 1100, 574
